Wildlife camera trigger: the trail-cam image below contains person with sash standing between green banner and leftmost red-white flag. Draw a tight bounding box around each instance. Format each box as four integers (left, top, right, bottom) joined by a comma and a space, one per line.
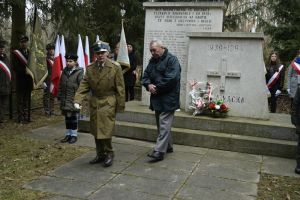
43, 43, 55, 117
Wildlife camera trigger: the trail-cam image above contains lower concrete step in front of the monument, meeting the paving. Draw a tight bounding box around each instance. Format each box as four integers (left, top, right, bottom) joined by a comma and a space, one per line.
80, 121, 296, 158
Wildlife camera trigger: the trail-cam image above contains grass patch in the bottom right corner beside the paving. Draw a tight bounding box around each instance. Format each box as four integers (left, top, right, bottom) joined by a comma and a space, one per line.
257, 174, 300, 200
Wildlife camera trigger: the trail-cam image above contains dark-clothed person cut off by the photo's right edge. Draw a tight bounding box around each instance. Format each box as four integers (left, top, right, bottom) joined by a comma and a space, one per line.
291, 76, 300, 174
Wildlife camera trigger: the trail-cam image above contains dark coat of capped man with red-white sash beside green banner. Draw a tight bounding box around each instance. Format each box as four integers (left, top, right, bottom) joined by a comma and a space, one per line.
12, 49, 33, 92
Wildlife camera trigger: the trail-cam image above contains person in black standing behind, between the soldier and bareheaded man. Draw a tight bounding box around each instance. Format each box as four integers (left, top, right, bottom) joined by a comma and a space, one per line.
124, 43, 137, 101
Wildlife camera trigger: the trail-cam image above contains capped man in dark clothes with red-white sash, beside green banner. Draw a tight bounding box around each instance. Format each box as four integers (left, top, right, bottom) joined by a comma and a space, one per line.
12, 35, 33, 123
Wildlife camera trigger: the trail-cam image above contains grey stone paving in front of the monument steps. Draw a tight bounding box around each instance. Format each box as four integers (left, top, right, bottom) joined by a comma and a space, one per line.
24, 124, 300, 200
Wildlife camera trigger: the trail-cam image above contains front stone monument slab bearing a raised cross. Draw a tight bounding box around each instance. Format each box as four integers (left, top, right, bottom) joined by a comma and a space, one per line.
185, 32, 269, 119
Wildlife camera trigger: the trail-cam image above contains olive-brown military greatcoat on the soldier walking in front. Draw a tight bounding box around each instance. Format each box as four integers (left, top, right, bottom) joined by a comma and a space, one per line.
75, 60, 125, 139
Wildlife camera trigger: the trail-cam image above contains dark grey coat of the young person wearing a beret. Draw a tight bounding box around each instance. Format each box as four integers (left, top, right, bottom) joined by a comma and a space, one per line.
57, 66, 84, 114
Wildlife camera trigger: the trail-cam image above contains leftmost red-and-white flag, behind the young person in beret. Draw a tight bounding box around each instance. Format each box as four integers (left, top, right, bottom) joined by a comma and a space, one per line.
50, 35, 62, 97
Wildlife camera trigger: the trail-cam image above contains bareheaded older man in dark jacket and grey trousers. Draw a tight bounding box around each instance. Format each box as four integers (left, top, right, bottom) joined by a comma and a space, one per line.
142, 40, 181, 162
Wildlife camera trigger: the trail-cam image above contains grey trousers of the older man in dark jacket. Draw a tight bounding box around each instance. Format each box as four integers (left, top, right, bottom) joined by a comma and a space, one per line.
154, 111, 174, 153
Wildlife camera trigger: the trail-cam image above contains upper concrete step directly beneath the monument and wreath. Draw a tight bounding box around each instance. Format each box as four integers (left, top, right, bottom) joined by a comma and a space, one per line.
113, 102, 297, 141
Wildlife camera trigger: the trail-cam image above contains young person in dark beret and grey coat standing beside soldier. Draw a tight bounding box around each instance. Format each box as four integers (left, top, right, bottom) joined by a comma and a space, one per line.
57, 54, 83, 144
